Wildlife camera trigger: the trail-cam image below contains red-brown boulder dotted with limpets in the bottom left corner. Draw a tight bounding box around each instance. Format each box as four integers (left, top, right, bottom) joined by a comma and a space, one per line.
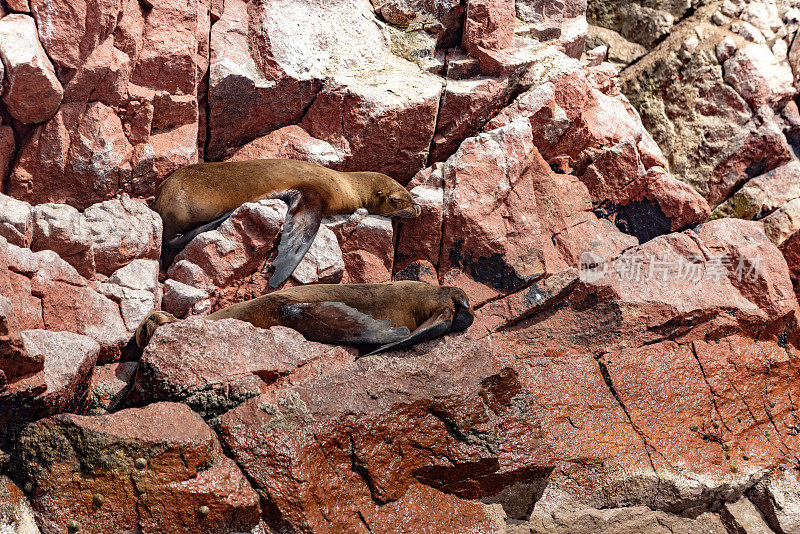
17, 403, 260, 533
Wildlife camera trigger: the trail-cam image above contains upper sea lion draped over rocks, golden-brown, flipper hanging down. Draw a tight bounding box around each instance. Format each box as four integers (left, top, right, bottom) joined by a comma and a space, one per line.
153, 159, 420, 287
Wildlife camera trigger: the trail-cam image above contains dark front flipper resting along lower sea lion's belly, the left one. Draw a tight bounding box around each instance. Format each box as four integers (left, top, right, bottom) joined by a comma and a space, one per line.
281, 302, 410, 345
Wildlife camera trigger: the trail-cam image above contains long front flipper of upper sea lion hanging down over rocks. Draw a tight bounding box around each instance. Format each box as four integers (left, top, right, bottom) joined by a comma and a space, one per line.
269, 191, 325, 287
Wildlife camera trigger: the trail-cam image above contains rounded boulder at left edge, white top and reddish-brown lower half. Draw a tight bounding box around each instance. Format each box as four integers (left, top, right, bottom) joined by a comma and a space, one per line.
0, 13, 64, 124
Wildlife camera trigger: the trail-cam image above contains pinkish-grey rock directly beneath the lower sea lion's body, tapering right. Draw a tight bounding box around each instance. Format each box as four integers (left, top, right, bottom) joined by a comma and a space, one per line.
131, 318, 355, 417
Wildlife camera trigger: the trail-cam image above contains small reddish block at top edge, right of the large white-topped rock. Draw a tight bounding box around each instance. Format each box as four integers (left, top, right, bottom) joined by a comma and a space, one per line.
461, 0, 515, 55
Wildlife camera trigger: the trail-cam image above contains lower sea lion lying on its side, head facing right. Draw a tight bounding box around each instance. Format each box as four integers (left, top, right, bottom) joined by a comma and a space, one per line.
136, 280, 474, 356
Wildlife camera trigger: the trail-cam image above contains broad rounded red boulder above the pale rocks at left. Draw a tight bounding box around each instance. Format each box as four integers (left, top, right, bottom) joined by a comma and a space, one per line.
9, 102, 132, 208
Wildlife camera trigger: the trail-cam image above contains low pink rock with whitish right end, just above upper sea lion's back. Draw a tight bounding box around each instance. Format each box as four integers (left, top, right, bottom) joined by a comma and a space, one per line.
226, 126, 344, 169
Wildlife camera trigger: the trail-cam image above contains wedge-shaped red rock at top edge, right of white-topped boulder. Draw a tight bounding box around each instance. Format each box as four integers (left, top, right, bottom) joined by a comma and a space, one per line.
29, 0, 122, 73
